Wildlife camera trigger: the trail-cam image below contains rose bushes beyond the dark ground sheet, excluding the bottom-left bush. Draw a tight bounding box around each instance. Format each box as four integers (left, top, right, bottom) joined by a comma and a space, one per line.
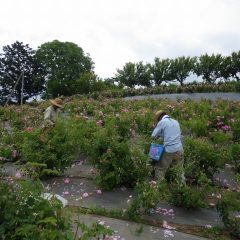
0, 98, 240, 237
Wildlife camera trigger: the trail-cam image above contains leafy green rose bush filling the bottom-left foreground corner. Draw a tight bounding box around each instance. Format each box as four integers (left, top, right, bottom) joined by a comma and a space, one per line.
0, 181, 73, 240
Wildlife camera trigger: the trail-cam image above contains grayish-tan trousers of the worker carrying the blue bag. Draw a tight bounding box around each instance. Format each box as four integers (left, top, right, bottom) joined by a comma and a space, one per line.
154, 150, 185, 184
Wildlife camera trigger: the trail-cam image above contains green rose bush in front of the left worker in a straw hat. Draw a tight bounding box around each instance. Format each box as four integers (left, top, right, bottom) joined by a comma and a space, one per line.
17, 121, 75, 176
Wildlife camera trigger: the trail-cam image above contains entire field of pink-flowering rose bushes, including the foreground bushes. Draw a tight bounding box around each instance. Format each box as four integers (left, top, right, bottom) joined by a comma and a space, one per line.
0, 96, 240, 239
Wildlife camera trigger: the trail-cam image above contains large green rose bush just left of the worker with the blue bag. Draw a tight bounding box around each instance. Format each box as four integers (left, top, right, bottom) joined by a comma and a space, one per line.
82, 123, 149, 189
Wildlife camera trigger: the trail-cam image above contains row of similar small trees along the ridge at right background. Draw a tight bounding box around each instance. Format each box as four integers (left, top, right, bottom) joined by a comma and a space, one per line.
113, 51, 240, 88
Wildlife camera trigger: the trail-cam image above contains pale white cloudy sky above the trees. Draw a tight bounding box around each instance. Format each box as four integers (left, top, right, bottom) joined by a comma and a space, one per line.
0, 0, 240, 78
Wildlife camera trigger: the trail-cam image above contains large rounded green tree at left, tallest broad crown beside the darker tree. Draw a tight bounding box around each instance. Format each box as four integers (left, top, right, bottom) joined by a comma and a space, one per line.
36, 40, 94, 97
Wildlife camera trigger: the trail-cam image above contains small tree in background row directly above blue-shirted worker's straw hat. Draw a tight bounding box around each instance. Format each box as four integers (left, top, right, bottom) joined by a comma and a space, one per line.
150, 58, 172, 86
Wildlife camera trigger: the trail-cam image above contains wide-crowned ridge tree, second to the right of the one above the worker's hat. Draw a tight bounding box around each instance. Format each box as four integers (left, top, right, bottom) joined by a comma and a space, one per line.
194, 54, 224, 83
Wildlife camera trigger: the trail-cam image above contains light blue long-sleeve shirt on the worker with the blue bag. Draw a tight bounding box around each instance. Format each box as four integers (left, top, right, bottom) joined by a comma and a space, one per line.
152, 115, 183, 153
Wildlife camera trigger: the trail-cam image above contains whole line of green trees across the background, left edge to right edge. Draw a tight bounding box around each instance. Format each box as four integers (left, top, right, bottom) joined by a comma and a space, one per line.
0, 40, 240, 104
